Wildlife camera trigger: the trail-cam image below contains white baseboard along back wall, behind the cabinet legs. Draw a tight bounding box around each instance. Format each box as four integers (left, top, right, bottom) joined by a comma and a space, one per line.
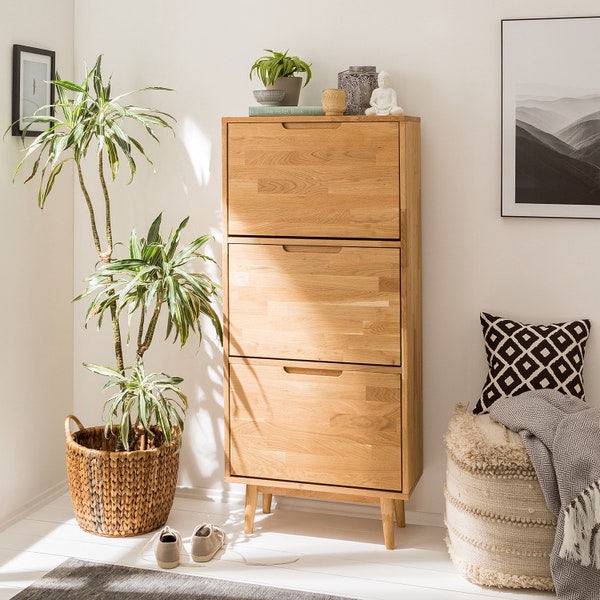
177, 484, 444, 527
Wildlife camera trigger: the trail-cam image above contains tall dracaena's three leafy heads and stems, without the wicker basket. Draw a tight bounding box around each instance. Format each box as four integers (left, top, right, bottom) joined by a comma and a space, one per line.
7, 56, 223, 450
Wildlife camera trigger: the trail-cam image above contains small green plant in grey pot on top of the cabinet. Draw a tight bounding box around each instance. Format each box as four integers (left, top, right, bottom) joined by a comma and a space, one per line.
249, 49, 312, 106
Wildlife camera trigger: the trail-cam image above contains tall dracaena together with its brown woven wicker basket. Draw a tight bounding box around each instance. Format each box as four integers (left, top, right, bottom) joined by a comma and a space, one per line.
7, 56, 223, 536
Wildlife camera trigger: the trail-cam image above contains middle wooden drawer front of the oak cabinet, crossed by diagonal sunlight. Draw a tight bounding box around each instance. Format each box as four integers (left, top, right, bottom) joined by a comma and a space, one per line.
227, 242, 401, 365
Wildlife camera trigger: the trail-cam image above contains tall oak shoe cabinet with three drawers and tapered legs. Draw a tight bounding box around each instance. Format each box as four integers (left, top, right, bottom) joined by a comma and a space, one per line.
222, 116, 423, 548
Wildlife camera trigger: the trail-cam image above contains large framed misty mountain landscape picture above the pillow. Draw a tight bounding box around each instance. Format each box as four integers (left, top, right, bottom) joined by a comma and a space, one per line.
501, 17, 600, 219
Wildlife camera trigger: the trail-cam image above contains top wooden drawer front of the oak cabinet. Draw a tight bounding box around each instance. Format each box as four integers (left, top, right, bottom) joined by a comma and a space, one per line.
225, 121, 400, 240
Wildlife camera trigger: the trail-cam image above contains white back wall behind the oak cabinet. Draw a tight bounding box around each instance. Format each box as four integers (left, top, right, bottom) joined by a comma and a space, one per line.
62, 0, 600, 514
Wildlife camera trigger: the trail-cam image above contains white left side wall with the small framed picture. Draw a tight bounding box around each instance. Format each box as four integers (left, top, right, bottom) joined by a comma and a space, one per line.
0, 0, 73, 522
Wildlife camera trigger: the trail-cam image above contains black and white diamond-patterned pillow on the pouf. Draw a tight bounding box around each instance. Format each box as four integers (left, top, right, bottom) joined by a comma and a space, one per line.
473, 312, 591, 414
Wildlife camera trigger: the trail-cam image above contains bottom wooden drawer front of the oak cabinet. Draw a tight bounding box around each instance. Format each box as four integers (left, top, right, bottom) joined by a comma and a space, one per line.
228, 359, 402, 491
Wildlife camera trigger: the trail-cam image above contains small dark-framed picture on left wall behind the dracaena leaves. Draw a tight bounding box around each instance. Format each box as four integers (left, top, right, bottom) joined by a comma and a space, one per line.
12, 44, 55, 136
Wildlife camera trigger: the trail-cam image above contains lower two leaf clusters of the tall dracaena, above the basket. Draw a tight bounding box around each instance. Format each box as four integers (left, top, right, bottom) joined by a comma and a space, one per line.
77, 214, 223, 449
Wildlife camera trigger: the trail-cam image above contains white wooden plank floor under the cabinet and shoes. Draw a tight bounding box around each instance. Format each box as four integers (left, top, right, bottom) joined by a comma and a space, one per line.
0, 494, 555, 600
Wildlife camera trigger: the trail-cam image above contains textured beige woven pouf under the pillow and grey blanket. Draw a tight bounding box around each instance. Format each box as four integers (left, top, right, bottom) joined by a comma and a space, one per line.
444, 406, 556, 591
